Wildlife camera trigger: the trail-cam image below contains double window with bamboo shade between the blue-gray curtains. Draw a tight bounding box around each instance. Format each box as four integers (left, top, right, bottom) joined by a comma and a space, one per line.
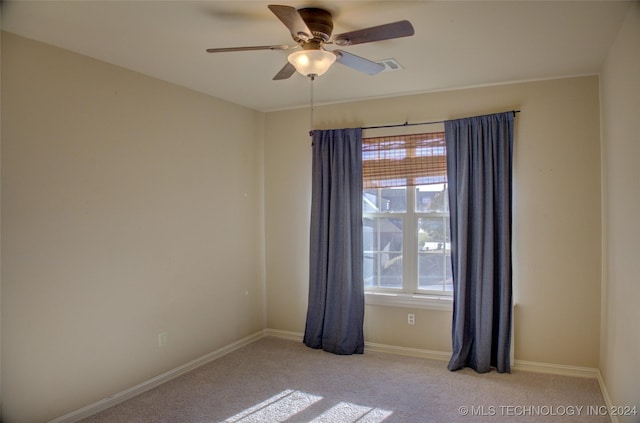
362, 132, 453, 304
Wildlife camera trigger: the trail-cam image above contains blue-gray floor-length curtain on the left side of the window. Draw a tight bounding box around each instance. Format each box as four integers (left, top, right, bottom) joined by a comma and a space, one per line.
304, 128, 364, 354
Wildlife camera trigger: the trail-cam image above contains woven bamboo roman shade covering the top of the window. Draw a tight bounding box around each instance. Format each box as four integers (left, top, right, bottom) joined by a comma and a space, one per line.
362, 132, 447, 189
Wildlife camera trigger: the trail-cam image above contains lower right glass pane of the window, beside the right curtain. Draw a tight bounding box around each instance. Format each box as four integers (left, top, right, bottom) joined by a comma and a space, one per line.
418, 216, 453, 291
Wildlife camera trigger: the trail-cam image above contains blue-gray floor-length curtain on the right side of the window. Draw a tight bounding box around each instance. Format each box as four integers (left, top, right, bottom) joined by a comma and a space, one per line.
445, 112, 514, 373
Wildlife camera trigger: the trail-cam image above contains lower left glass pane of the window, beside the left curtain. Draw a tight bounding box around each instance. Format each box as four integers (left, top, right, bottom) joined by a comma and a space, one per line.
363, 217, 402, 288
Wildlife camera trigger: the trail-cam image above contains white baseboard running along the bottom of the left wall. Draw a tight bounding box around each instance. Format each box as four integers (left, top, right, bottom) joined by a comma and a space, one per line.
48, 331, 265, 423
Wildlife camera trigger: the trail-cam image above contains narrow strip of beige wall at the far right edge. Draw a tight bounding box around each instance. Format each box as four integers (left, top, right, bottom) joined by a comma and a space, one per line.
600, 2, 640, 422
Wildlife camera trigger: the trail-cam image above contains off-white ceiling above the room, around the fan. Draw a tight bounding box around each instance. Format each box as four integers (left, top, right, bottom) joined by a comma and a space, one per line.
2, 0, 631, 111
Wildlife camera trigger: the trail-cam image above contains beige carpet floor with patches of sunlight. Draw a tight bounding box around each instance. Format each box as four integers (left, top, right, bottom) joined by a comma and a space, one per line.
83, 338, 610, 423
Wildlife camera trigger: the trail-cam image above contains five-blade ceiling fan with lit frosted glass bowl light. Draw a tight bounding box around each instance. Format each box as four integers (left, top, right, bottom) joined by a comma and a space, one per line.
207, 4, 414, 80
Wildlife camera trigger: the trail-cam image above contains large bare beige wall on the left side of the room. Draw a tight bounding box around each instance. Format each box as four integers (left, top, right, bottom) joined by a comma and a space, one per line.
2, 34, 265, 422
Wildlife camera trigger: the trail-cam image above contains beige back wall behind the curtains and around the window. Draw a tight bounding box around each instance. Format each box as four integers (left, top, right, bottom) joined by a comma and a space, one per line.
265, 76, 601, 367
